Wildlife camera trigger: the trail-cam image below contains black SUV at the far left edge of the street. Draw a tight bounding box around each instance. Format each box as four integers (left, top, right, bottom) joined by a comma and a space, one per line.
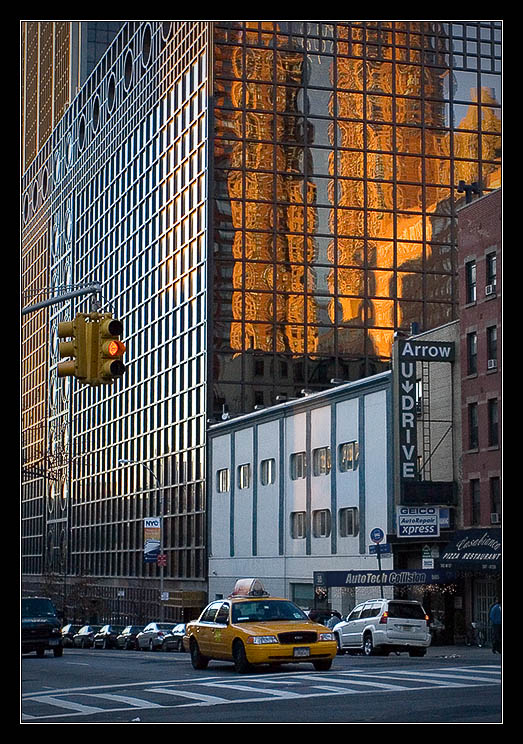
22, 597, 63, 656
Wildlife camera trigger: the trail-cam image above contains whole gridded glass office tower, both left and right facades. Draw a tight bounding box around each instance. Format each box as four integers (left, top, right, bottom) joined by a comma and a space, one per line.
22, 21, 502, 619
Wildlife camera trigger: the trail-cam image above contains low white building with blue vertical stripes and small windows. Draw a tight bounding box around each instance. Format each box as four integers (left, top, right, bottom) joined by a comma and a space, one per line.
208, 372, 394, 612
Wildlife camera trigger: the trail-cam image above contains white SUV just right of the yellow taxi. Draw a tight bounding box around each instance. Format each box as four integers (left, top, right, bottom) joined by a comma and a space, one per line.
334, 599, 431, 656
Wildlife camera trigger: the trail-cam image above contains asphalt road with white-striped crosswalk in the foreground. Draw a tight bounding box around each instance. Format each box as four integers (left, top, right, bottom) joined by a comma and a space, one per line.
21, 647, 502, 724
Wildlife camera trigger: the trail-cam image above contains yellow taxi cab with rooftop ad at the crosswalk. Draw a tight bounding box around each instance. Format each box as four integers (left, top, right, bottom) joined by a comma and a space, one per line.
184, 579, 337, 673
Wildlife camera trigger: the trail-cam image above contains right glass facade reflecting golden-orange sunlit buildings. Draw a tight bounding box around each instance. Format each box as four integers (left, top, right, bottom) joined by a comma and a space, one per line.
213, 21, 501, 413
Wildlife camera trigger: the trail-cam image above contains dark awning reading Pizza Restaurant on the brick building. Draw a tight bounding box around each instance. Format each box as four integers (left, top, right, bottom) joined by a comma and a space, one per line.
440, 527, 501, 571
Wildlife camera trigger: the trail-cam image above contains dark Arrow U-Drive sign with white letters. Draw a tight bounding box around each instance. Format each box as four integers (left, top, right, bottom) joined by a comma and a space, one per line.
398, 339, 454, 480
